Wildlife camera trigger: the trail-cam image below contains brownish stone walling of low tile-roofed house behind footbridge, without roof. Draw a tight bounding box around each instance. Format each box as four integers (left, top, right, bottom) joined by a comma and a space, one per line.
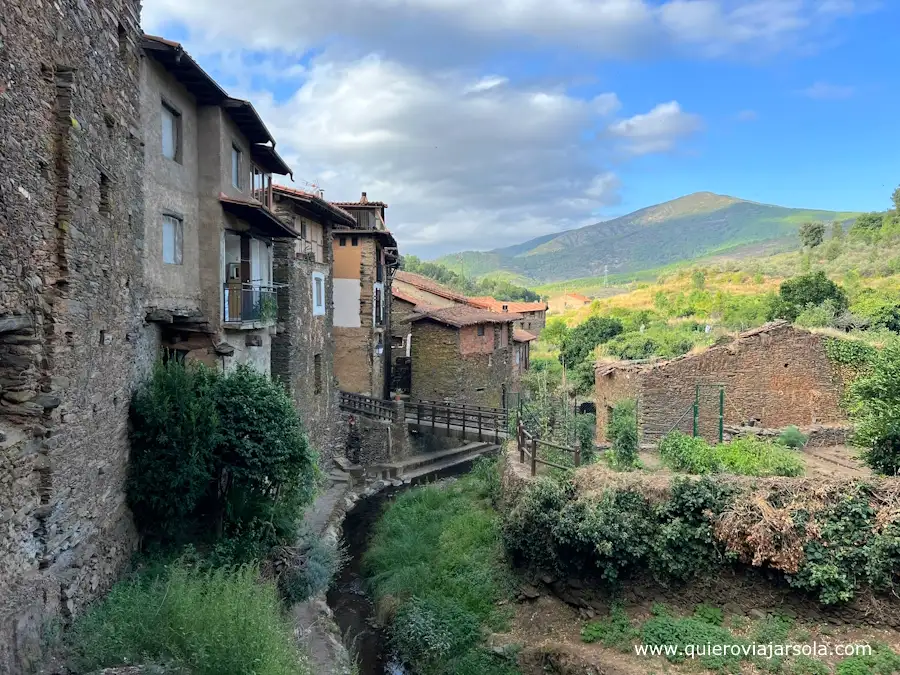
411, 320, 512, 408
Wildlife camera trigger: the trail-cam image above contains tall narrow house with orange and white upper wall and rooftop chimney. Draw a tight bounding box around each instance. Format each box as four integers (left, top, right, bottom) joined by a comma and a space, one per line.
332, 192, 397, 399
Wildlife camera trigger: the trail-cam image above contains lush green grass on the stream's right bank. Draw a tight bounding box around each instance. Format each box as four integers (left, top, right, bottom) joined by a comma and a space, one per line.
364, 460, 517, 675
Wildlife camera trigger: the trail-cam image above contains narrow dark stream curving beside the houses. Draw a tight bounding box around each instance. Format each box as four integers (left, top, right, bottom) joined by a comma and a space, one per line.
327, 462, 486, 675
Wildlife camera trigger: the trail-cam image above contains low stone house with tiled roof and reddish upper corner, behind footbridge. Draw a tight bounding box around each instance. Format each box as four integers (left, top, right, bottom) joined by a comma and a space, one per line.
410, 305, 519, 408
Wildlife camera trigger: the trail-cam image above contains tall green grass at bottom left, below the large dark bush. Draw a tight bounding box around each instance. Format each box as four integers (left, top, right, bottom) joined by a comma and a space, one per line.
67, 562, 310, 675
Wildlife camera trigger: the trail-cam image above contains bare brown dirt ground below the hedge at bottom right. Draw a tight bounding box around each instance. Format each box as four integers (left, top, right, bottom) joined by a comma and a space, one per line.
491, 595, 900, 675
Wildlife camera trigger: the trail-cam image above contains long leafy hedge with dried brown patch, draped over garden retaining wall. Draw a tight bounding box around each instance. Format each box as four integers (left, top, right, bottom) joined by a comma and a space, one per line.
503, 464, 900, 605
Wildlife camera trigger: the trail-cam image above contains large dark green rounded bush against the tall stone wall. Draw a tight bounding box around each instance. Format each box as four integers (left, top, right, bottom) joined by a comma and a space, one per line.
128, 361, 316, 562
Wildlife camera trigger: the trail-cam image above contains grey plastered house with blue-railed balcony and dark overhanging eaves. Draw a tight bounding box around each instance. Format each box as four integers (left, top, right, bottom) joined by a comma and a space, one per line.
141, 35, 299, 374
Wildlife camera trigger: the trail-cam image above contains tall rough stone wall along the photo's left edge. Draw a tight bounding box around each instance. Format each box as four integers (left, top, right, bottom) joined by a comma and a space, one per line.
0, 0, 143, 673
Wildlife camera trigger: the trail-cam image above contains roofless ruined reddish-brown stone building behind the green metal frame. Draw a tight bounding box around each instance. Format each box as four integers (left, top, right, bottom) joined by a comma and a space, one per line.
595, 321, 849, 443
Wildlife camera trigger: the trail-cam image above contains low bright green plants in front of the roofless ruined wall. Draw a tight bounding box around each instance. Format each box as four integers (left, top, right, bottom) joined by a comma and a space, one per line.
659, 430, 805, 476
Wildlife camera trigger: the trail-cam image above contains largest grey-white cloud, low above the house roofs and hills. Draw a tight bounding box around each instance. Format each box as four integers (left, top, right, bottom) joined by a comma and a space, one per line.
237, 56, 632, 253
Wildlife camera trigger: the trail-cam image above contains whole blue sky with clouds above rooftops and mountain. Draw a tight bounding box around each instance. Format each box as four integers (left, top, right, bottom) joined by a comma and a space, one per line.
143, 0, 900, 257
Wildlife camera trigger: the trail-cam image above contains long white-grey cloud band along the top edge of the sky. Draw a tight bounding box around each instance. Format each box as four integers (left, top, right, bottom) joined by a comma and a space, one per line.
143, 0, 871, 64
